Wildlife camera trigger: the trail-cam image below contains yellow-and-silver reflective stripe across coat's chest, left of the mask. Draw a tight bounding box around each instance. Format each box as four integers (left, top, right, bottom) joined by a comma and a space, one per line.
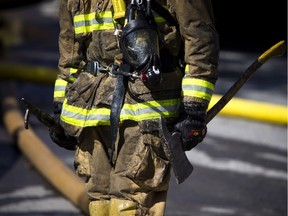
74, 11, 114, 34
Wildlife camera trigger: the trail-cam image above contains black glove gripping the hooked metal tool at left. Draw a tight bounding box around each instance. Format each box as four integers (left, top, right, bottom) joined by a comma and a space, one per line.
49, 103, 77, 150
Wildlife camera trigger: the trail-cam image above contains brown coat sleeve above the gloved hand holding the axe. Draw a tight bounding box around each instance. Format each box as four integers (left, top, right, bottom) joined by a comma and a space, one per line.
168, 0, 219, 106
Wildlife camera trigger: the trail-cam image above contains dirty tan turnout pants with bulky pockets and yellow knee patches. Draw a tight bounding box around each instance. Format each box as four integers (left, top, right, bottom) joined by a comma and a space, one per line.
75, 121, 171, 216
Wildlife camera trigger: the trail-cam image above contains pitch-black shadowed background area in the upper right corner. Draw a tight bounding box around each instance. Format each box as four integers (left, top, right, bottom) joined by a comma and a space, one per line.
212, 0, 287, 52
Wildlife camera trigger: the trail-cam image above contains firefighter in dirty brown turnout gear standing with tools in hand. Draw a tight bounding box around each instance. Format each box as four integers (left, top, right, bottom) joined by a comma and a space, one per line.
50, 0, 219, 216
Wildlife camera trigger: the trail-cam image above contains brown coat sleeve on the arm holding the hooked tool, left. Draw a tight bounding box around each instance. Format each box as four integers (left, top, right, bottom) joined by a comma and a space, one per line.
54, 0, 83, 102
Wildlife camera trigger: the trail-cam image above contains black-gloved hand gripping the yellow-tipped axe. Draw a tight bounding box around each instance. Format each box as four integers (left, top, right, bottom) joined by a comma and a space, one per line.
175, 103, 207, 151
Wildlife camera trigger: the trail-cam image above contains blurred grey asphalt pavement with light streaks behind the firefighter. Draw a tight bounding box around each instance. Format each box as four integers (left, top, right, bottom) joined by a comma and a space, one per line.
0, 1, 287, 216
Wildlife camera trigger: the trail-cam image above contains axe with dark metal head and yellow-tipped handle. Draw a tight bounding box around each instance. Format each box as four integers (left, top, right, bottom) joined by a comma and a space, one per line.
159, 41, 286, 184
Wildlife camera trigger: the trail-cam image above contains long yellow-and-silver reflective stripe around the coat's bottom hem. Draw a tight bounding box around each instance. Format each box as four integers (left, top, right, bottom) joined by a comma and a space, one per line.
61, 99, 180, 127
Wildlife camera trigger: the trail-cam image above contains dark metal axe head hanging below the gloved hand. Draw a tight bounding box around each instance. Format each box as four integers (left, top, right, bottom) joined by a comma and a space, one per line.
159, 117, 193, 184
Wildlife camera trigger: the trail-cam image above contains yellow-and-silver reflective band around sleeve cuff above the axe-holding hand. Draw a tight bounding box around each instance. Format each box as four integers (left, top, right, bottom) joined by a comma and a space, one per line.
182, 76, 215, 101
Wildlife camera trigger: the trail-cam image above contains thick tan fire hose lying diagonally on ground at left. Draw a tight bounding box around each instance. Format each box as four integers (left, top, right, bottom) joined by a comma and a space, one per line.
2, 96, 89, 215
